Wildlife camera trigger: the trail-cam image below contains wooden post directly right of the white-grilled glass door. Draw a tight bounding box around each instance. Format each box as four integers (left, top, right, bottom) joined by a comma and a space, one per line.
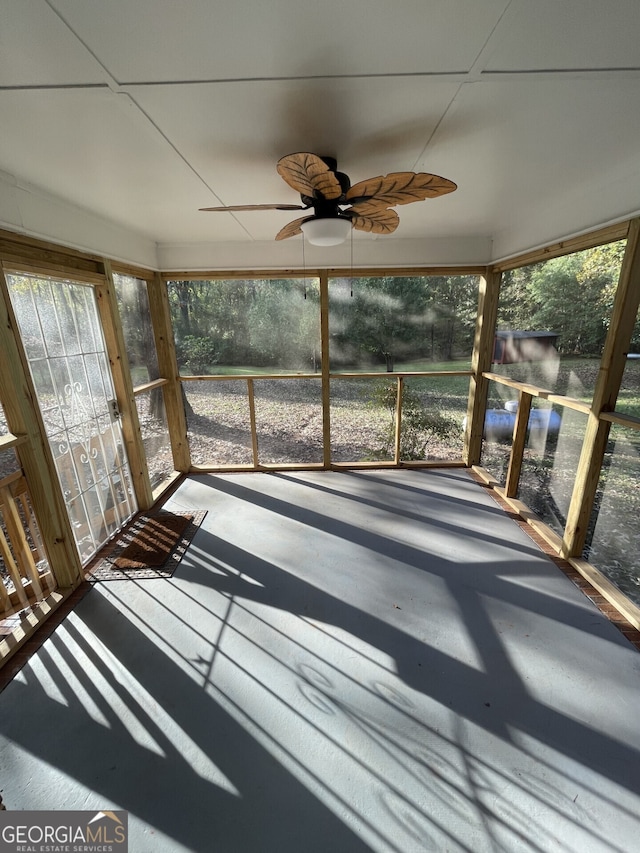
95, 260, 153, 510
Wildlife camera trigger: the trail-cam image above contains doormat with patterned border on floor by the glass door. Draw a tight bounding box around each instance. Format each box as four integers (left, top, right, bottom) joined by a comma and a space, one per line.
86, 509, 207, 583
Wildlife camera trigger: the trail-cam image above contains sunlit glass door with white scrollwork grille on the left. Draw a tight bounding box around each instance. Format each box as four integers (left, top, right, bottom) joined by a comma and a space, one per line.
7, 274, 137, 562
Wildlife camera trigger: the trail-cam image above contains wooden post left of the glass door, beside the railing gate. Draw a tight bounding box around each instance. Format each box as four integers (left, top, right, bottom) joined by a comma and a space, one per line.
0, 265, 84, 588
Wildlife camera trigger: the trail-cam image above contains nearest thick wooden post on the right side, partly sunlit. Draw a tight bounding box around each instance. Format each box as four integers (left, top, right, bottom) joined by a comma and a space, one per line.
561, 219, 640, 557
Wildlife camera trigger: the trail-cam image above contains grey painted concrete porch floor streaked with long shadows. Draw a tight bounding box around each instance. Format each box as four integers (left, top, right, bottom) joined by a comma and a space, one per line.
0, 469, 640, 853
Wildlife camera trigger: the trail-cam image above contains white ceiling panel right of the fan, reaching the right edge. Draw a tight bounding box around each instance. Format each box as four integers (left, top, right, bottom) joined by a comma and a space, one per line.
432, 79, 640, 251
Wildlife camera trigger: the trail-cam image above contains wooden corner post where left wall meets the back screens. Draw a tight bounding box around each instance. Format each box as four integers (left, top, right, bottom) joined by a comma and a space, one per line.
147, 273, 191, 474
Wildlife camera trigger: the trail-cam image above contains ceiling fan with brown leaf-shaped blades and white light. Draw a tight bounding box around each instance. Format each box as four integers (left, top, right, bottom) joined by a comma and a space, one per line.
200, 152, 457, 246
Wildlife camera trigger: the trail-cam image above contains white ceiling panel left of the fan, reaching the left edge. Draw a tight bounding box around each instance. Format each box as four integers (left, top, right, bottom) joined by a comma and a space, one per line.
0, 89, 242, 241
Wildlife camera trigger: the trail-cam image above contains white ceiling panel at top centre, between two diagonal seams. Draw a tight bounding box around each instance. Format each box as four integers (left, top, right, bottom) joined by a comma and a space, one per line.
52, 0, 508, 83
